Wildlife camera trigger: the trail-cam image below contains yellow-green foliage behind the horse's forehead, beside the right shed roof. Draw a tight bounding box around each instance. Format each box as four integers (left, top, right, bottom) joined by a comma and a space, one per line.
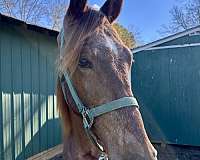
113, 23, 136, 49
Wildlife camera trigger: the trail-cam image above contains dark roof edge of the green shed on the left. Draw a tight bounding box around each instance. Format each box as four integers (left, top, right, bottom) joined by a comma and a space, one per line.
0, 13, 59, 37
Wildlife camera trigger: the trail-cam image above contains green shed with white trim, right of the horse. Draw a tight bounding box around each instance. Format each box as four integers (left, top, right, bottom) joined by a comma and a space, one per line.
132, 26, 200, 146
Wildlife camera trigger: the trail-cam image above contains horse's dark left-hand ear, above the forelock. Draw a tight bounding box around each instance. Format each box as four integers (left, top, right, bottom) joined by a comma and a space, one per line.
67, 0, 87, 18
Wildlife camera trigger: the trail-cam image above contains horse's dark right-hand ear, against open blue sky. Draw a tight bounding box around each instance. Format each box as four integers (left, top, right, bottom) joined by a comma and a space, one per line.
100, 0, 123, 23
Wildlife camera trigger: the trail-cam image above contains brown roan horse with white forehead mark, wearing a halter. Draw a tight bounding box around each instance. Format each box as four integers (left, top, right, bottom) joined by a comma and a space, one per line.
56, 0, 157, 160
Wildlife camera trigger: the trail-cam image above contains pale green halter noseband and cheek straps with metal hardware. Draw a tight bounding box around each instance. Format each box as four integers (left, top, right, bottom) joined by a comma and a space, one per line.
59, 72, 139, 160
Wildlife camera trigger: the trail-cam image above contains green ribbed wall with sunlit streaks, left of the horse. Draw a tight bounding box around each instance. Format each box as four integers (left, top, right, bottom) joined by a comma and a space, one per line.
0, 22, 61, 160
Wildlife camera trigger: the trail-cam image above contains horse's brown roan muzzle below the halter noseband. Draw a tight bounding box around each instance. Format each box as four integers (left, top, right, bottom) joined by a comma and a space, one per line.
95, 108, 157, 160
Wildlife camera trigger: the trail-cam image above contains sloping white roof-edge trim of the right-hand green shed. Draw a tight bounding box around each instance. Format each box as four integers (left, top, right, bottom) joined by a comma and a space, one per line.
133, 25, 200, 53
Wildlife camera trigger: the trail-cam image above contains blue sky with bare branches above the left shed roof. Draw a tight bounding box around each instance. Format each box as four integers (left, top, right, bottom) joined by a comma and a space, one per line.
0, 0, 67, 29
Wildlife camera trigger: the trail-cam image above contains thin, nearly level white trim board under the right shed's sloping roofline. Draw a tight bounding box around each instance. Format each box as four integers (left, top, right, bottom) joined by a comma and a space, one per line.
145, 43, 200, 51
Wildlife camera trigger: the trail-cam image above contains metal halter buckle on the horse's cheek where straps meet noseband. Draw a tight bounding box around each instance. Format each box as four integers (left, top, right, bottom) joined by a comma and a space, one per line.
81, 108, 94, 129
